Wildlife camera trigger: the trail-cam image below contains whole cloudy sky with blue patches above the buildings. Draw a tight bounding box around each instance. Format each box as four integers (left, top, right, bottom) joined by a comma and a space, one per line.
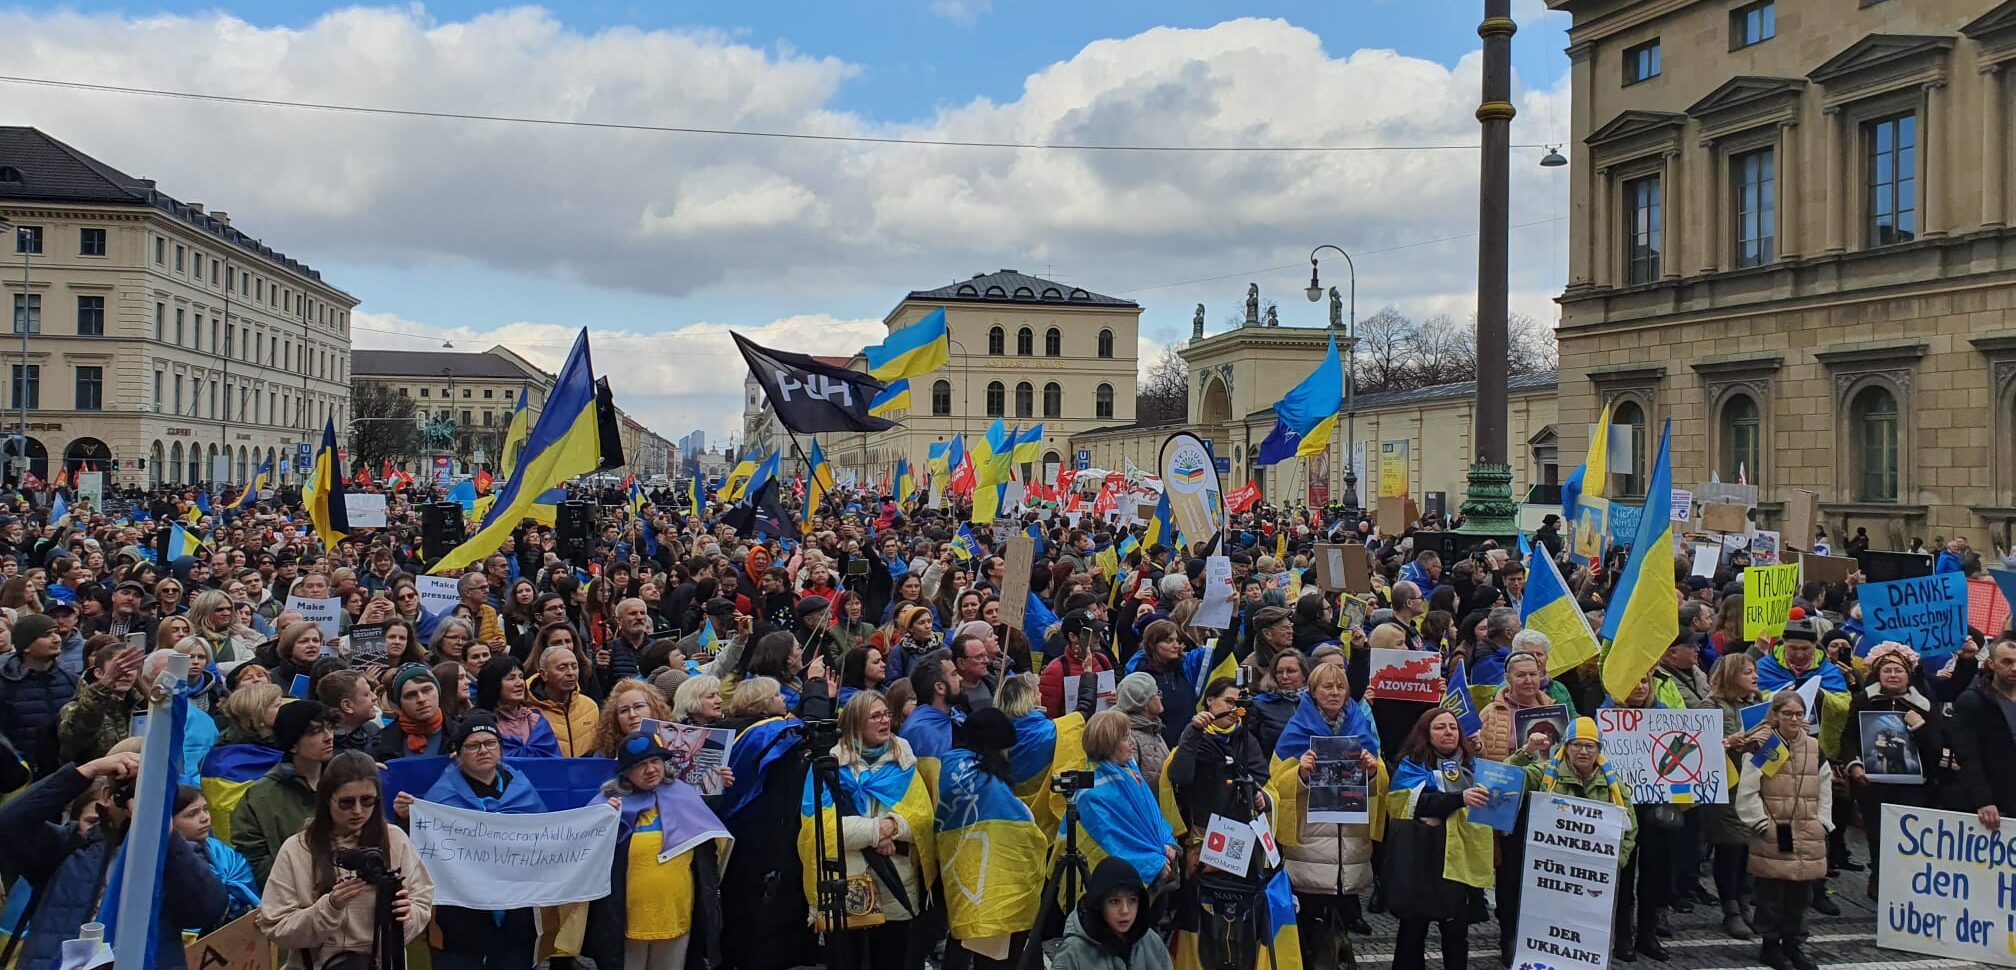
0, 0, 1568, 440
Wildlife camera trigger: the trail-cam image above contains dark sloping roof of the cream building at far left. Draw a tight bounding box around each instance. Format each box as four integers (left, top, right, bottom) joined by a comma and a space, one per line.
0, 125, 357, 294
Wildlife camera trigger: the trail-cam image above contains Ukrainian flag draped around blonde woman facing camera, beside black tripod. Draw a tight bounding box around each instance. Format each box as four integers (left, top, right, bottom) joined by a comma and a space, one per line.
794, 738, 935, 930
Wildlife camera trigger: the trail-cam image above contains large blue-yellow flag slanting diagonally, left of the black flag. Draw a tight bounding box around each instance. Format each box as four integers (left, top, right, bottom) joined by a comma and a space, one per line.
433, 329, 603, 573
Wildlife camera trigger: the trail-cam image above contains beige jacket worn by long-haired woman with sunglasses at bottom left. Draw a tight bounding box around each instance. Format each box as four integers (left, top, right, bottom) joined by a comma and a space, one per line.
256, 825, 433, 970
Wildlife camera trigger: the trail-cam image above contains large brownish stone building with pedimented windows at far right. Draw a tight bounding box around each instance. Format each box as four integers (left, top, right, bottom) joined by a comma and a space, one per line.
1548, 0, 2016, 549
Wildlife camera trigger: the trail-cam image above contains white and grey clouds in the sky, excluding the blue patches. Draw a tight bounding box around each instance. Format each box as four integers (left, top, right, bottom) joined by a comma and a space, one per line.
0, 8, 1568, 434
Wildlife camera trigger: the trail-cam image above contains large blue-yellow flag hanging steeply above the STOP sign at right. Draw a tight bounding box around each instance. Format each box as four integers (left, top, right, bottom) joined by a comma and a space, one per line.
1603, 417, 1679, 700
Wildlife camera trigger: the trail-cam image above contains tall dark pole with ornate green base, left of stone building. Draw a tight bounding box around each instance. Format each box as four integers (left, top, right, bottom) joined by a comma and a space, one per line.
1462, 0, 1518, 538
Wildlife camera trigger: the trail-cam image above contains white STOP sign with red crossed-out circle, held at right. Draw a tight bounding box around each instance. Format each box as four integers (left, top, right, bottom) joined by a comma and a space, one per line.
1597, 701, 1725, 805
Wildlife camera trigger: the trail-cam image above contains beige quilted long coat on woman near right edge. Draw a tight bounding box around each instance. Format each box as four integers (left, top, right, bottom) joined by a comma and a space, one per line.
1736, 734, 1835, 883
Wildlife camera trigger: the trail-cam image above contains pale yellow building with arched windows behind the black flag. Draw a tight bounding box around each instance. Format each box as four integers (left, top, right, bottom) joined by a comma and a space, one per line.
810, 270, 1141, 480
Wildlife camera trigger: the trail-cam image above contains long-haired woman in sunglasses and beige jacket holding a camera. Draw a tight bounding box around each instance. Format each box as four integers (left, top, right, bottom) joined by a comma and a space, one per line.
258, 750, 433, 968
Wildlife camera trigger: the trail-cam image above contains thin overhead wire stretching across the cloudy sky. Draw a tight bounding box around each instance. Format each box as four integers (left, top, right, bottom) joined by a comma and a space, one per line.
0, 75, 1546, 155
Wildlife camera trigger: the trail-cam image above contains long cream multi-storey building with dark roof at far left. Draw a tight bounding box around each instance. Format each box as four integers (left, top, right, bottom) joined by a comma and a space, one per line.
0, 127, 357, 484
